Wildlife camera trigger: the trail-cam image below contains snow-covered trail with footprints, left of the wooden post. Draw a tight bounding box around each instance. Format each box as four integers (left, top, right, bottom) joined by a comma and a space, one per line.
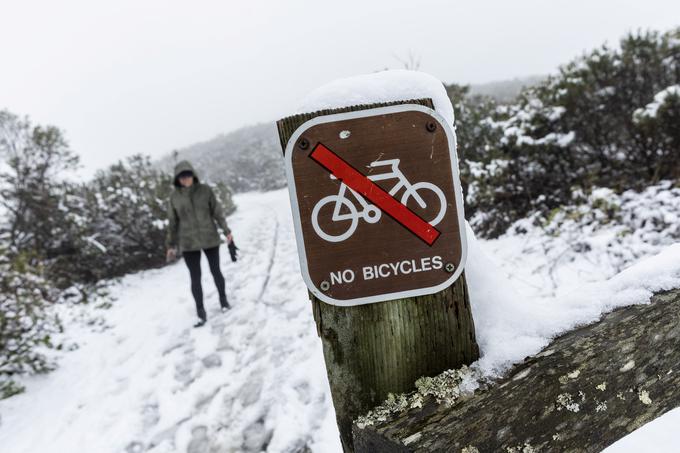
0, 191, 339, 453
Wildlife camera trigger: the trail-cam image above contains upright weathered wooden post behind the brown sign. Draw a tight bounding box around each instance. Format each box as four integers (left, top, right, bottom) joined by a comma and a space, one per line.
277, 99, 479, 452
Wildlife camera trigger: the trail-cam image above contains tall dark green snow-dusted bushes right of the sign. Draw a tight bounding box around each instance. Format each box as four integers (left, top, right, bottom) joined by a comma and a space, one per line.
450, 29, 680, 237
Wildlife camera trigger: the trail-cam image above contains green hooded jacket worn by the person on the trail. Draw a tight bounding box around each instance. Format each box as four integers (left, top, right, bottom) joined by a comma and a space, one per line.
166, 160, 231, 253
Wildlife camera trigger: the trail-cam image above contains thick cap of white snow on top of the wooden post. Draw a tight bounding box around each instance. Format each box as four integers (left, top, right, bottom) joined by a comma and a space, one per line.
297, 69, 454, 125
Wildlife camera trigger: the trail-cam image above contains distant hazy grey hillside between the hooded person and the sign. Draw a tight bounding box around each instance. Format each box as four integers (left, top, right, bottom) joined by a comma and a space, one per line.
159, 122, 286, 192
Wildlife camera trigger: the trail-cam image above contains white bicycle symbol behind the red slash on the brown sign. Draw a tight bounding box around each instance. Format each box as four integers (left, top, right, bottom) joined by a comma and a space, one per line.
312, 159, 446, 242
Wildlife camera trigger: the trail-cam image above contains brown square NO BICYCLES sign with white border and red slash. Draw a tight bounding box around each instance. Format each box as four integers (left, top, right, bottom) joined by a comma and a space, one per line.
285, 104, 466, 305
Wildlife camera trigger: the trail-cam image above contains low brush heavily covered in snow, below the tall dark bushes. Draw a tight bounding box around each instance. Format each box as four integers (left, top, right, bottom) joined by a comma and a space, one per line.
486, 181, 680, 294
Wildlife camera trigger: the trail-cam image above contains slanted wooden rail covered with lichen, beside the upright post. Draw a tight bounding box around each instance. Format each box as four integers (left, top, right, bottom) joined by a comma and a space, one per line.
354, 289, 680, 453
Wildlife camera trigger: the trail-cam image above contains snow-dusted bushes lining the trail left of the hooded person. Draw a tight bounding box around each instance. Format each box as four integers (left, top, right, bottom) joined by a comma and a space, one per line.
0, 111, 235, 398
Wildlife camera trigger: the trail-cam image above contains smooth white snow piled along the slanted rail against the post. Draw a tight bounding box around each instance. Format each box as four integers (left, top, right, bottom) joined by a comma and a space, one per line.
467, 231, 680, 377
